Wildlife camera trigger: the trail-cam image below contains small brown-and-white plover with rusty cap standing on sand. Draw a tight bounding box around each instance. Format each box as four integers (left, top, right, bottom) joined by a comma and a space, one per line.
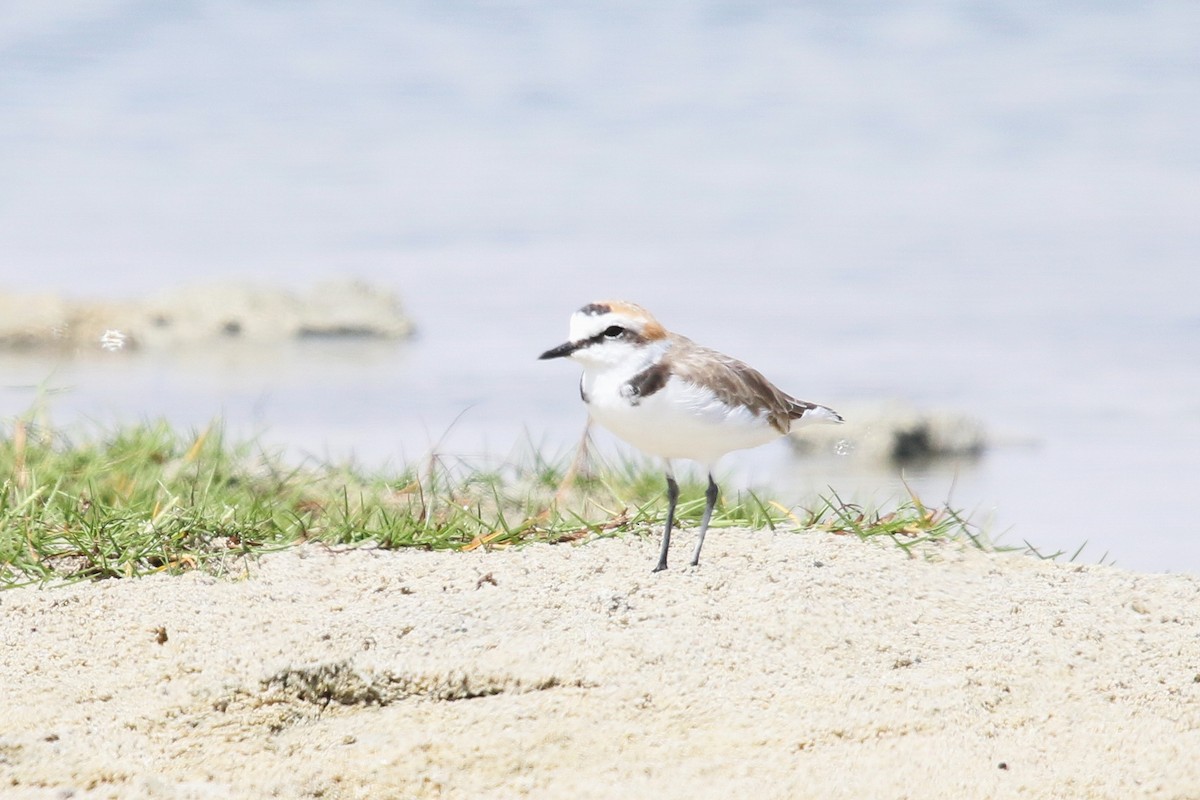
539, 300, 842, 572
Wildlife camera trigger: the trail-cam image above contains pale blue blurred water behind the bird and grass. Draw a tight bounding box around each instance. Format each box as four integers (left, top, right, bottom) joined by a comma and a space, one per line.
0, 0, 1200, 571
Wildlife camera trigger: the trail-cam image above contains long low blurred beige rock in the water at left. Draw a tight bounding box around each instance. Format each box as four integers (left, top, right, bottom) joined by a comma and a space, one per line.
0, 281, 413, 351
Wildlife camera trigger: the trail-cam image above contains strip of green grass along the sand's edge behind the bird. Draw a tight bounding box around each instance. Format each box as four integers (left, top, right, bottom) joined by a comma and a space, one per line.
0, 419, 983, 587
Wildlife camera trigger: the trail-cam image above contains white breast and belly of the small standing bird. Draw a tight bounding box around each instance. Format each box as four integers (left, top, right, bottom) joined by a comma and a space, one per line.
583, 375, 782, 464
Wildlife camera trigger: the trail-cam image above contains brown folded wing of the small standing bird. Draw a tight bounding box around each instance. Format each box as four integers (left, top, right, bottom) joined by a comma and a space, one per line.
667, 333, 816, 433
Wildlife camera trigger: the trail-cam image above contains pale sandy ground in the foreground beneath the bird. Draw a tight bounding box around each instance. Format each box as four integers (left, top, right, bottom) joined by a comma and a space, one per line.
0, 530, 1200, 800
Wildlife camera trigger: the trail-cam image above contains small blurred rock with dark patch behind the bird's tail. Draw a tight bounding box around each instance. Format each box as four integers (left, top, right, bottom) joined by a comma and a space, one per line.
788, 403, 988, 464
